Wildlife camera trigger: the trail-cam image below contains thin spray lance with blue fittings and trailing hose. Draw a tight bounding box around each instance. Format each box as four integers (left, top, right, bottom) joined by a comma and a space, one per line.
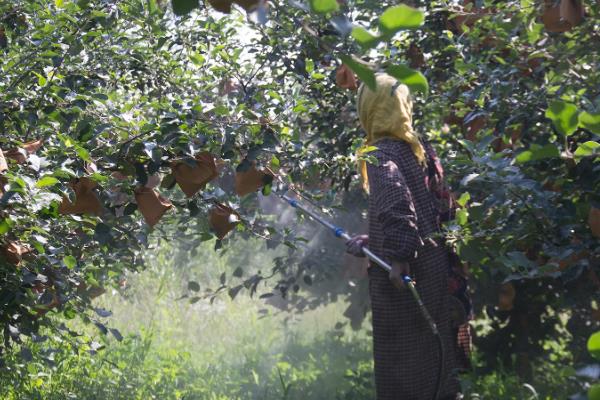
280, 194, 444, 400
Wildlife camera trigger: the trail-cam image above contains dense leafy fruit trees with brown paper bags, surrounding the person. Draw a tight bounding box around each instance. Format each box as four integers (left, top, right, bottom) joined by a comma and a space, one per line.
0, 0, 600, 384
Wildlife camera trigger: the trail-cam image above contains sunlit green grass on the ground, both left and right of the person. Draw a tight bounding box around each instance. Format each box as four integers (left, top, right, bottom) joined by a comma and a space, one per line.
0, 239, 579, 400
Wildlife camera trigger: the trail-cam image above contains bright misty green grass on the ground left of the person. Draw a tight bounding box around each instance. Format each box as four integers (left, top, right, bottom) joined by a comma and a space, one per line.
2, 290, 372, 400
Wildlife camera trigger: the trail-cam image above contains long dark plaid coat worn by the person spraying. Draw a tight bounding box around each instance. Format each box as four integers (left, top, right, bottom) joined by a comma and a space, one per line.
367, 139, 459, 400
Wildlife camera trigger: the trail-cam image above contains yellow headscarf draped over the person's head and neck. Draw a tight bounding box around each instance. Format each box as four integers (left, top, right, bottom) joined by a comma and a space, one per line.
357, 73, 426, 192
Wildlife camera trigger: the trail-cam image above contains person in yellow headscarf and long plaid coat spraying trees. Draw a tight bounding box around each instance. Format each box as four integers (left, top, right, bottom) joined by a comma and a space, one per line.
347, 73, 466, 400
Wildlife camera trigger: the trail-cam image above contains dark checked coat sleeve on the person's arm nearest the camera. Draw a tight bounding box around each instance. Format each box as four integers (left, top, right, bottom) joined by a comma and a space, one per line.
367, 151, 422, 262
